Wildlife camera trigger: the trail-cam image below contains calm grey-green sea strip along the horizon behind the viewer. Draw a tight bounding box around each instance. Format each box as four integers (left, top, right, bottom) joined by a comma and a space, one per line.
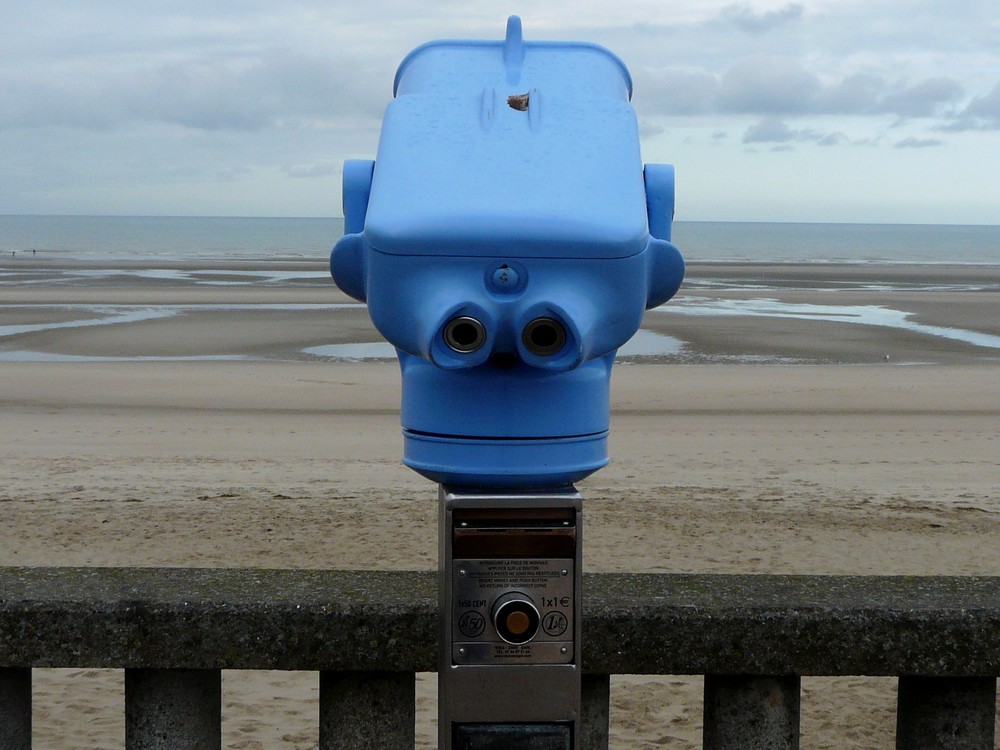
0, 216, 1000, 265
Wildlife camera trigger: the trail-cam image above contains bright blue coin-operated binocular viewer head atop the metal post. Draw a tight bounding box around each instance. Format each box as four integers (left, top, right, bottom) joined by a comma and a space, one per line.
330, 17, 684, 488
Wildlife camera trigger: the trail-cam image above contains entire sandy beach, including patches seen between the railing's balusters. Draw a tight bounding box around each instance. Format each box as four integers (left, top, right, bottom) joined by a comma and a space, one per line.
0, 260, 1000, 750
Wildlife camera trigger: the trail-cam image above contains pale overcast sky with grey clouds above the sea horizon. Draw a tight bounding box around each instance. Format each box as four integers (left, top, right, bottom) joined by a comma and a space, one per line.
0, 0, 1000, 224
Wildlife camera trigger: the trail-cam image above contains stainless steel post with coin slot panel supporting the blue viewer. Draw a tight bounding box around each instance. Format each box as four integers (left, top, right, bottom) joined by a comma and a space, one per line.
438, 486, 583, 750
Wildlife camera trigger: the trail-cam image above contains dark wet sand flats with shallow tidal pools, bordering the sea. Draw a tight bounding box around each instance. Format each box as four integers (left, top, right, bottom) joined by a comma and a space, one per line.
0, 261, 1000, 364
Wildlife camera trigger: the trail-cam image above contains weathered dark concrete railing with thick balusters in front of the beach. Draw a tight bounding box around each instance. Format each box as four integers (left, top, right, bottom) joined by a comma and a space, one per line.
0, 568, 1000, 750
